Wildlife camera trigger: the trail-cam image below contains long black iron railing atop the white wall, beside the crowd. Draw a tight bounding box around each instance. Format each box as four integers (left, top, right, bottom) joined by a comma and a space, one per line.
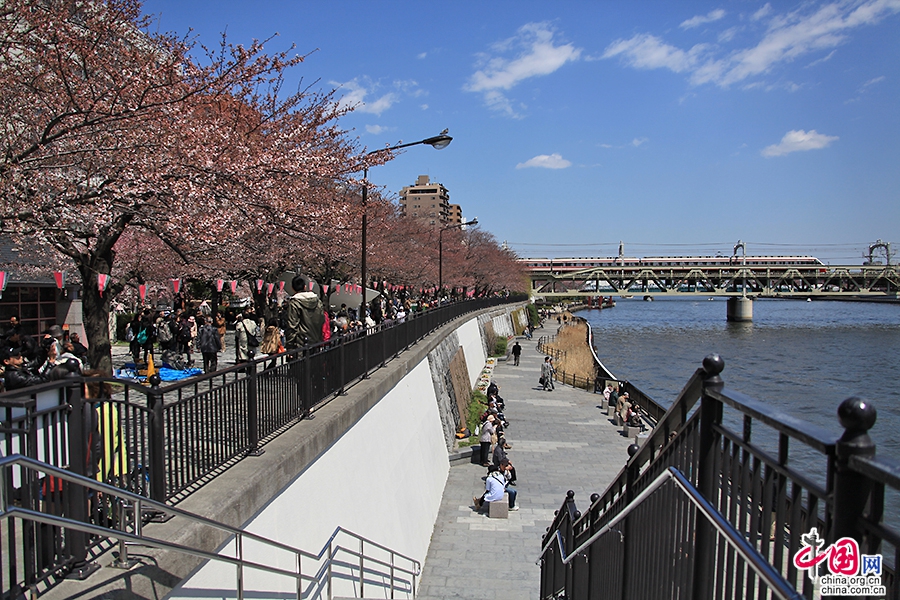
0, 298, 521, 596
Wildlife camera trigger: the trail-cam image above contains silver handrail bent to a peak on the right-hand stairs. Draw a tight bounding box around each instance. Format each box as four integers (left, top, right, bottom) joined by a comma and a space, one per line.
536, 467, 802, 600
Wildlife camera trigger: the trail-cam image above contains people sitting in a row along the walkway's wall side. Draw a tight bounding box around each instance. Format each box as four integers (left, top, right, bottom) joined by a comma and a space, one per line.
472, 381, 519, 511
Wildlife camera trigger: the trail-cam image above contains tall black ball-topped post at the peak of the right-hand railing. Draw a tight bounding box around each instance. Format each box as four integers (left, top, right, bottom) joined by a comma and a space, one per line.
693, 354, 725, 600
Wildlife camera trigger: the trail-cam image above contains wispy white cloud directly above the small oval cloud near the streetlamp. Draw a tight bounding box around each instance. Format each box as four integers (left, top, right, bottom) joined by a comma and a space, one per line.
463, 23, 581, 116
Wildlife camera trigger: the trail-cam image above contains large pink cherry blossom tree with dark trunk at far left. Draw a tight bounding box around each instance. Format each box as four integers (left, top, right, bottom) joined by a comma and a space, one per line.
0, 0, 358, 371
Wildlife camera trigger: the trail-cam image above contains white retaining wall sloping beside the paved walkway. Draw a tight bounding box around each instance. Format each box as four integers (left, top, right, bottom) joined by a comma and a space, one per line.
169, 315, 496, 598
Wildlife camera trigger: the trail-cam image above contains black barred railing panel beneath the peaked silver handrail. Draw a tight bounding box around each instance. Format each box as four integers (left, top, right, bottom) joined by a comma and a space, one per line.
538, 467, 801, 599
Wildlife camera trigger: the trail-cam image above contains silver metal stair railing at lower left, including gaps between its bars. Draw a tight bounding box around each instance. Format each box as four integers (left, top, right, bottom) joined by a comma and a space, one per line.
0, 455, 421, 600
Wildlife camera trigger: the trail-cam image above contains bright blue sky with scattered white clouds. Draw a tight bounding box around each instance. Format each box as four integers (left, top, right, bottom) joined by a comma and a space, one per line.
144, 0, 900, 264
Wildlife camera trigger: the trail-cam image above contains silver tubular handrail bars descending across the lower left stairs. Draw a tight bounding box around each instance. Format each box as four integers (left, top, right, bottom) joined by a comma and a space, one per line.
0, 454, 421, 599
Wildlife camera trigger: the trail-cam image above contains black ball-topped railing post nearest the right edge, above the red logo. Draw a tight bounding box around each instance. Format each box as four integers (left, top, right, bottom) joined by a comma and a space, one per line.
830, 397, 878, 547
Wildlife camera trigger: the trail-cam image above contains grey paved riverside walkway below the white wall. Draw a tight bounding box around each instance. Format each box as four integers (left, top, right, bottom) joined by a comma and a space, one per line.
416, 338, 631, 600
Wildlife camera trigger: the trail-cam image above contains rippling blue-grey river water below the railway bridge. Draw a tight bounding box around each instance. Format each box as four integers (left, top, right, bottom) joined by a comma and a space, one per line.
578, 297, 900, 548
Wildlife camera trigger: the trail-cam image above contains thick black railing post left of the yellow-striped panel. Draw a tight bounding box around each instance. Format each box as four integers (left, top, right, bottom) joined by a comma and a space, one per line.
65, 380, 100, 579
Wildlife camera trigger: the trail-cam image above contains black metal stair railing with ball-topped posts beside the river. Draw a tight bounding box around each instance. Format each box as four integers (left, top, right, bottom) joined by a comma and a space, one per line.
541, 355, 900, 600
